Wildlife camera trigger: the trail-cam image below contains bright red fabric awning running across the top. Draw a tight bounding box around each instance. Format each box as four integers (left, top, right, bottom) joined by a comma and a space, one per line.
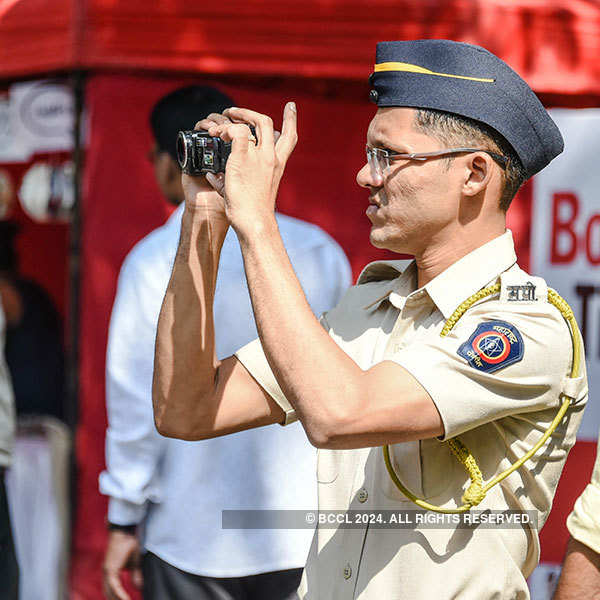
0, 0, 600, 95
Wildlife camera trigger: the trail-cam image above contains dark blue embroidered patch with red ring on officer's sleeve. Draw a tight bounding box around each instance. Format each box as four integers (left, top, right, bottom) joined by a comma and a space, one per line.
457, 321, 524, 373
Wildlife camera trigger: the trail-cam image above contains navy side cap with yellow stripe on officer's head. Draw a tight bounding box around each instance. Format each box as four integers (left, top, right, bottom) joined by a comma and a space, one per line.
369, 40, 564, 177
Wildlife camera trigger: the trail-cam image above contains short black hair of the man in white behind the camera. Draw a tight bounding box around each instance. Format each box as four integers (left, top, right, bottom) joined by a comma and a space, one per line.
150, 85, 233, 160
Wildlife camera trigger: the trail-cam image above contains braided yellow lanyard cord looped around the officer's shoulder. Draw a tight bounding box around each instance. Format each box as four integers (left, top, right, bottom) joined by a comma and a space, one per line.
382, 283, 582, 514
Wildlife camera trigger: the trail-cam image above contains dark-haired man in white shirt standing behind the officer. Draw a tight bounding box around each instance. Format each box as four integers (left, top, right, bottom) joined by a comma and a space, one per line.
100, 86, 350, 600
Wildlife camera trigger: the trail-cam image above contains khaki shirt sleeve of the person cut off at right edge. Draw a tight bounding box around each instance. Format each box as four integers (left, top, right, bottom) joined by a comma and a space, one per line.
567, 440, 600, 553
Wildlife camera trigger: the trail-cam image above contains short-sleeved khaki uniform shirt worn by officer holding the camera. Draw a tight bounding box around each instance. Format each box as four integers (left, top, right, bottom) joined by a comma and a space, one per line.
237, 231, 587, 600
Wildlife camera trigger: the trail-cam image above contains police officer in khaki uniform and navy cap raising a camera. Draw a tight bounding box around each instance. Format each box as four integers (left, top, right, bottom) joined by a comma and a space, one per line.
153, 40, 587, 599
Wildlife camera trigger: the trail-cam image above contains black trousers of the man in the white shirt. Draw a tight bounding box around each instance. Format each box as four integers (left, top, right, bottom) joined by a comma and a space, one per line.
142, 552, 302, 600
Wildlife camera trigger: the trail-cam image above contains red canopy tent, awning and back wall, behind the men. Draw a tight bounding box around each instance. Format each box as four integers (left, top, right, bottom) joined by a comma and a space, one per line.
0, 0, 600, 599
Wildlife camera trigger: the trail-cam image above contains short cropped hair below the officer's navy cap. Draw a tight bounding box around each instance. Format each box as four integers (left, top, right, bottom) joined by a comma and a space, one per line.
414, 108, 527, 212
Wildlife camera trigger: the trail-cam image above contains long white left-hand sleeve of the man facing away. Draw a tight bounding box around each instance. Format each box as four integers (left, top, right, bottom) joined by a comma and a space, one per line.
100, 257, 167, 525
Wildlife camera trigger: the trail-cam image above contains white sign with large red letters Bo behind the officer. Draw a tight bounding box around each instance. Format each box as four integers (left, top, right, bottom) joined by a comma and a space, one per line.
531, 109, 600, 440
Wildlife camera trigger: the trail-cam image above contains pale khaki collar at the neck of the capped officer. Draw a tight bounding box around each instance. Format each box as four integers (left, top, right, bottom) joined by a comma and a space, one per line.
424, 229, 517, 319
